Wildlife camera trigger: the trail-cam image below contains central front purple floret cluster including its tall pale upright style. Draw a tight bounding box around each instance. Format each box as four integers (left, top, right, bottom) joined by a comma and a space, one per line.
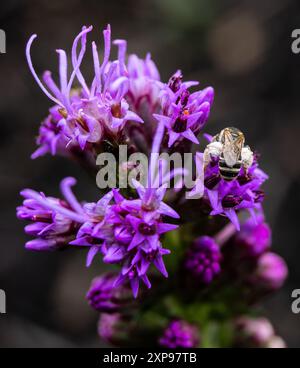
71, 119, 179, 298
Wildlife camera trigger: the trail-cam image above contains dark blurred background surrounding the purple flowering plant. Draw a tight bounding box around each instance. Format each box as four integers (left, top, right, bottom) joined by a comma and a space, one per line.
0, 0, 300, 347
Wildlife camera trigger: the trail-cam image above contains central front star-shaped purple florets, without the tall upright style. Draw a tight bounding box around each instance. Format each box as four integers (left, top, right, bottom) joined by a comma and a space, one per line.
71, 190, 177, 297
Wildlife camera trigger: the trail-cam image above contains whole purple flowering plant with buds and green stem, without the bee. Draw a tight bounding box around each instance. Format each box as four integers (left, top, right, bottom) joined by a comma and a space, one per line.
17, 26, 287, 348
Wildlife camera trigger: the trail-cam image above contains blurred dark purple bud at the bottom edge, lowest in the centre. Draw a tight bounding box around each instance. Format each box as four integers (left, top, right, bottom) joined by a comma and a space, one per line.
159, 320, 199, 349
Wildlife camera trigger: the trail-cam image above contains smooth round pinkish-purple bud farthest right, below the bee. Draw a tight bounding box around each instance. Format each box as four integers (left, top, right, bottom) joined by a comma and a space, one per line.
251, 252, 288, 291
